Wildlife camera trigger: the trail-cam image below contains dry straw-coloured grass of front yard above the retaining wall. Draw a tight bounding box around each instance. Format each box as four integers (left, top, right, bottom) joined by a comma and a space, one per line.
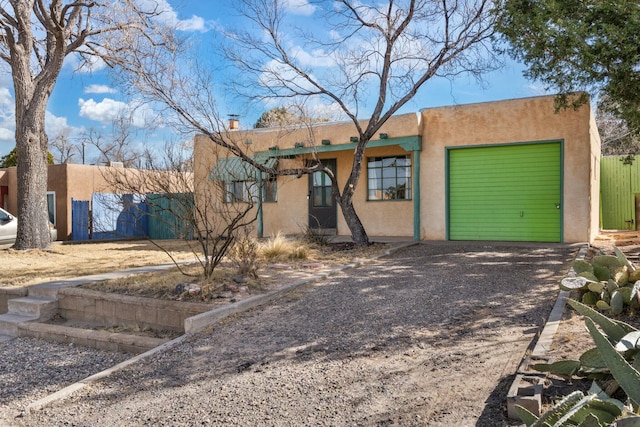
0, 235, 386, 301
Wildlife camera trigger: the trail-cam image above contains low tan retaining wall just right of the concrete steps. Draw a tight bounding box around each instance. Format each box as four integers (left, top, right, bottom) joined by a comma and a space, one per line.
58, 288, 211, 332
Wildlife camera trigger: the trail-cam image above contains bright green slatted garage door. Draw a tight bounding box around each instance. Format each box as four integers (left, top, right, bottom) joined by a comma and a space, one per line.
448, 142, 562, 242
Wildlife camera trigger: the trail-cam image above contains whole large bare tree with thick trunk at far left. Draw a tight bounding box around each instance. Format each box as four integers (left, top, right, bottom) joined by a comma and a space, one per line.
0, 0, 156, 249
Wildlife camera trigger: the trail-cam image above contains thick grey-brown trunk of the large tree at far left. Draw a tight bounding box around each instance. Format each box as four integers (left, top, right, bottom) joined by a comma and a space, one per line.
14, 115, 51, 250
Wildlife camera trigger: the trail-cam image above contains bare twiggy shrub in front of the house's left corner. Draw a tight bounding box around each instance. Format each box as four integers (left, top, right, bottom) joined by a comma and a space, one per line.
104, 141, 260, 278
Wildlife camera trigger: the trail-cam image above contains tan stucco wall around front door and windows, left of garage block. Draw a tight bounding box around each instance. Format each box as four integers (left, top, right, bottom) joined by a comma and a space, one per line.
194, 113, 420, 236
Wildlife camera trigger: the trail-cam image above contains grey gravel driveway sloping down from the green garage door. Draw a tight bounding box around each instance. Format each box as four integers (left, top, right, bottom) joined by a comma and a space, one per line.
0, 242, 577, 426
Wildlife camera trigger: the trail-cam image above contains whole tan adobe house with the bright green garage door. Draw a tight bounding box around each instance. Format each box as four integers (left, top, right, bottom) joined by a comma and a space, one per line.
199, 96, 600, 243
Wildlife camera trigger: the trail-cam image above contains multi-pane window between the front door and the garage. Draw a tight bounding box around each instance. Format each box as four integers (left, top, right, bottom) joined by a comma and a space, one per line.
367, 156, 411, 200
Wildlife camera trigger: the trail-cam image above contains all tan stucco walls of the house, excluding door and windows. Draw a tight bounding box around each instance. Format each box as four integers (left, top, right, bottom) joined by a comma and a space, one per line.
194, 96, 600, 242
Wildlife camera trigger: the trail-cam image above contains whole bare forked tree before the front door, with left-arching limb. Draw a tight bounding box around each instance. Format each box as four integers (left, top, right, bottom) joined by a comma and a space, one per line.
119, 0, 499, 245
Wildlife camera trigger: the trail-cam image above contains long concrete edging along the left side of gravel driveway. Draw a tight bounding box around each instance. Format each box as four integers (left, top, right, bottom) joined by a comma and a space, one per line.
26, 241, 420, 411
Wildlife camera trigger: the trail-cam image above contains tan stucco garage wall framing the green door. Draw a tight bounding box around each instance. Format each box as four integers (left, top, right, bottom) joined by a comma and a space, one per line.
421, 96, 600, 242
